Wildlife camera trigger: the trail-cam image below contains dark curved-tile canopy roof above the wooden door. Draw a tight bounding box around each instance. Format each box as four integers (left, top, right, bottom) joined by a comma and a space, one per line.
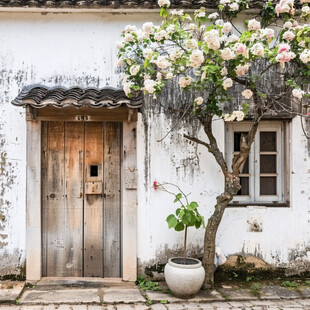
12, 85, 143, 108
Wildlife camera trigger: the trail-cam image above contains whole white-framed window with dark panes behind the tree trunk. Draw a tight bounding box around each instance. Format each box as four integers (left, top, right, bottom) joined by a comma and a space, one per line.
226, 121, 289, 206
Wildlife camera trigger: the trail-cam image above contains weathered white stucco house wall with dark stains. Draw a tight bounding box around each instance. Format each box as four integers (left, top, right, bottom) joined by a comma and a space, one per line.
0, 13, 310, 276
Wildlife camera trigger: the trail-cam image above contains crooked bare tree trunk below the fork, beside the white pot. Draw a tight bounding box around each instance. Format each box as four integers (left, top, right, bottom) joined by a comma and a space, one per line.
202, 178, 241, 288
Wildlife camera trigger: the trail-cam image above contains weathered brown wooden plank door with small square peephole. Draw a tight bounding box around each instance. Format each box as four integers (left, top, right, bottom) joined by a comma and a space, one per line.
42, 122, 121, 277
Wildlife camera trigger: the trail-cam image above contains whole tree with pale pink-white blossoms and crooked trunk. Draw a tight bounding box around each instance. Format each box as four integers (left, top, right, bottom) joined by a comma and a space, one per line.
118, 0, 310, 287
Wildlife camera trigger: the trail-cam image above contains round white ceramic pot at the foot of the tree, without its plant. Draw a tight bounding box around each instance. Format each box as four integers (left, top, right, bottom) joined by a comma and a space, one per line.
165, 257, 205, 299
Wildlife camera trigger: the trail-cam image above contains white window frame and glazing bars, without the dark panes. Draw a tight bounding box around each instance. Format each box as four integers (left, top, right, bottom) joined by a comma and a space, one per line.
225, 121, 288, 204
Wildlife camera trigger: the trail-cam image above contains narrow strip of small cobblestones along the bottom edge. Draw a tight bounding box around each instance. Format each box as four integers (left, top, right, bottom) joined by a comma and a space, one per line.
0, 299, 310, 310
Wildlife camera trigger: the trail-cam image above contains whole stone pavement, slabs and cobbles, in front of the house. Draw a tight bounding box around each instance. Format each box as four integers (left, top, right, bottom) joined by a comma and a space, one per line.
0, 278, 310, 310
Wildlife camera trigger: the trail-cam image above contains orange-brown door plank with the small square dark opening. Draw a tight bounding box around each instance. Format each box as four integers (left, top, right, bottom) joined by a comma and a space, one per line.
84, 123, 103, 277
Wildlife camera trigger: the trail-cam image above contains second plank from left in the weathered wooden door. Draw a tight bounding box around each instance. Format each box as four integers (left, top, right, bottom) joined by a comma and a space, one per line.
63, 122, 84, 277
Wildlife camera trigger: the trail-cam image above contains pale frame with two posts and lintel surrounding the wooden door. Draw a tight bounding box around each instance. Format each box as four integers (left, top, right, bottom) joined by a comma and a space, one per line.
26, 108, 137, 281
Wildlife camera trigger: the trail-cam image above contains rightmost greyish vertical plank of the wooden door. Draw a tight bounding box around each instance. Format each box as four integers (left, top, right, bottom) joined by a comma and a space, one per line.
103, 123, 121, 277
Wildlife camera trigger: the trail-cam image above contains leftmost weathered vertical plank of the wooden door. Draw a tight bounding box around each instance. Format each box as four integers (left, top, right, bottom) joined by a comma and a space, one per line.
42, 122, 65, 277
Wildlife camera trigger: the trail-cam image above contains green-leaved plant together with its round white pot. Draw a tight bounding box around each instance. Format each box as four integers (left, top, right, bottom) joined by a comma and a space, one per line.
153, 181, 205, 299
